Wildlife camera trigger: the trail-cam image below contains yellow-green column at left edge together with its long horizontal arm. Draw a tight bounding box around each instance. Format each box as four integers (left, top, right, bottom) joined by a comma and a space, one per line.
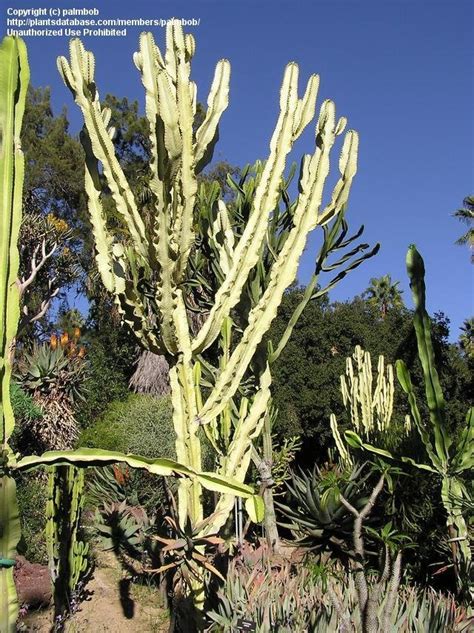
0, 37, 256, 633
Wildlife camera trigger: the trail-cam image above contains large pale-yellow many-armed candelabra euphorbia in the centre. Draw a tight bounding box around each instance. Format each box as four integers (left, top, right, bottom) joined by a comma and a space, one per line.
58, 21, 366, 600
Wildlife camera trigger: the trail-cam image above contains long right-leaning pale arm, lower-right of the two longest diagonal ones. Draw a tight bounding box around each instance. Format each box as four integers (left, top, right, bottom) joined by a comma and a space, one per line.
199, 122, 357, 422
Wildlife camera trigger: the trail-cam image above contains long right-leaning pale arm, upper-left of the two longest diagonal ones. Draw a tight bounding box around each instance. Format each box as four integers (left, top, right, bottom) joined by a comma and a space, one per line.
193, 64, 317, 353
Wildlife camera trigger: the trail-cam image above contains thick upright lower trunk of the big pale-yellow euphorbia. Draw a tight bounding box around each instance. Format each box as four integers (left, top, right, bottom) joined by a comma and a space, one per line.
170, 290, 203, 527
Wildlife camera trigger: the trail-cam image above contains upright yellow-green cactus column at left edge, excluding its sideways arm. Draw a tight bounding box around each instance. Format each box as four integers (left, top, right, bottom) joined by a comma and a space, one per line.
0, 37, 29, 633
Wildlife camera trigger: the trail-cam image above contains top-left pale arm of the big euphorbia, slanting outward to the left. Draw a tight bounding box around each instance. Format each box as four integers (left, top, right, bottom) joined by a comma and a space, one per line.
58, 39, 147, 260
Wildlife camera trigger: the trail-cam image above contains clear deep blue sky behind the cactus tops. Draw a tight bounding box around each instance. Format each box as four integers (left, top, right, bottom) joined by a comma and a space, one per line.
2, 0, 474, 339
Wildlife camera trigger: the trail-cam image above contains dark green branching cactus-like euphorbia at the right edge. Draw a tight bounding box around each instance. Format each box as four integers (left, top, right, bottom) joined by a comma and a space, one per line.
345, 245, 474, 598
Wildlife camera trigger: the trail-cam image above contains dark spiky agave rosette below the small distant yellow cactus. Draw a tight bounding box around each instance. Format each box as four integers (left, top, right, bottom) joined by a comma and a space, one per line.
276, 464, 370, 552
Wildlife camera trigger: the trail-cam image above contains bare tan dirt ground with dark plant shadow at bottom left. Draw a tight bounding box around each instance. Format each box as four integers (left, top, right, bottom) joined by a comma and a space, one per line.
19, 567, 168, 633
